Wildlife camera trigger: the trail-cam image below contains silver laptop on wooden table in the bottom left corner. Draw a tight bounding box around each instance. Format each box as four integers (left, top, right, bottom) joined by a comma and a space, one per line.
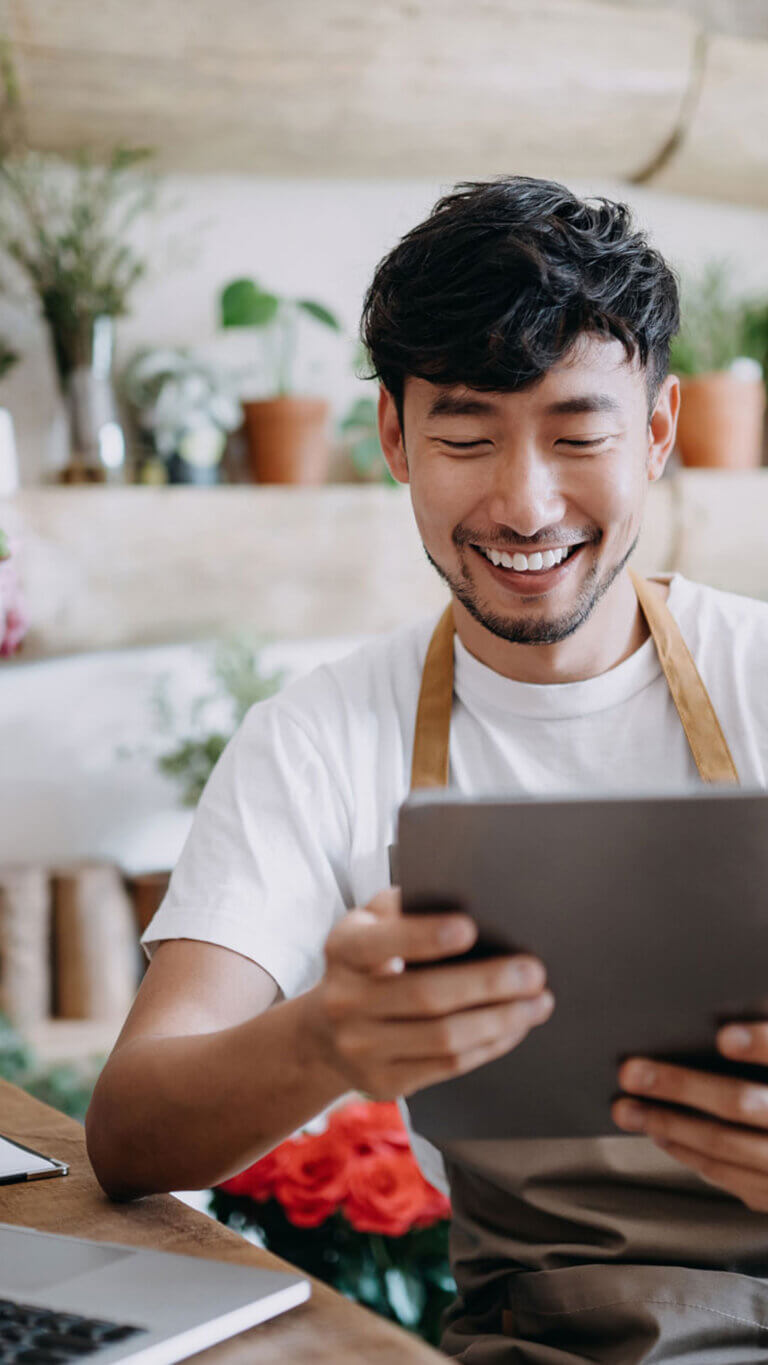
0, 1223, 310, 1365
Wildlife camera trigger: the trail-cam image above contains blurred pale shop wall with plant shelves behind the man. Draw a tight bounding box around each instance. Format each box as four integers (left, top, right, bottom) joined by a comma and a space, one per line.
0, 0, 768, 1337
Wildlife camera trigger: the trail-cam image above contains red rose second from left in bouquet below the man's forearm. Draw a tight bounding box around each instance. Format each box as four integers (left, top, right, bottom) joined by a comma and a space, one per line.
273, 1132, 349, 1227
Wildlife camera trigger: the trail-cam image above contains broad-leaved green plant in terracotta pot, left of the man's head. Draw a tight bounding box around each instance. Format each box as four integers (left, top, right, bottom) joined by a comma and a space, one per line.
220, 280, 341, 483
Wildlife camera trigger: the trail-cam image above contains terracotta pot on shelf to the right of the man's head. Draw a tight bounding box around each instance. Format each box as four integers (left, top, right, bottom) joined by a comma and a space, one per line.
677, 370, 765, 470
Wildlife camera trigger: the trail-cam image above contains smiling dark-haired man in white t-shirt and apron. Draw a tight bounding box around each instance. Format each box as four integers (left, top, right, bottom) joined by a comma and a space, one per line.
89, 177, 768, 1365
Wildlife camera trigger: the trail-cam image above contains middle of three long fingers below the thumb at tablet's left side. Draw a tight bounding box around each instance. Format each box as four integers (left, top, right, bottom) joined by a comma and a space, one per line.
344, 991, 555, 1063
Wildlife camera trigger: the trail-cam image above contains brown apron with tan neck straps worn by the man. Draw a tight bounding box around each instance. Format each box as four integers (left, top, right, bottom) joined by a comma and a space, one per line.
411, 575, 768, 1365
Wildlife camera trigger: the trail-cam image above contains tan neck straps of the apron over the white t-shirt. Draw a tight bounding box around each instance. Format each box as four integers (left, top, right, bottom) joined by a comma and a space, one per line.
411, 569, 739, 790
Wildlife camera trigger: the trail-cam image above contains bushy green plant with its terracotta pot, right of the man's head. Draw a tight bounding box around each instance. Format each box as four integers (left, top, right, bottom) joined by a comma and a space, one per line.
670, 265, 768, 470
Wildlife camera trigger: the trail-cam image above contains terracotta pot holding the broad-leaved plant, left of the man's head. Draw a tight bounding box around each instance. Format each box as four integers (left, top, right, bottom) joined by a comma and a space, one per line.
243, 397, 330, 483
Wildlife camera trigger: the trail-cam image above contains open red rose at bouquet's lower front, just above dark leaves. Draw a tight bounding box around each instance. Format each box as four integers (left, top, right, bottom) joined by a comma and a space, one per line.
342, 1149, 424, 1237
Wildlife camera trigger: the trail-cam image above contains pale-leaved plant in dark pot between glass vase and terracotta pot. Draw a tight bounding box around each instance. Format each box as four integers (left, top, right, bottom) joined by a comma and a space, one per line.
121, 347, 240, 485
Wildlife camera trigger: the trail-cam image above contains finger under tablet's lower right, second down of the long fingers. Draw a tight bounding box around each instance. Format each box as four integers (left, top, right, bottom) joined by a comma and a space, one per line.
614, 1100, 768, 1174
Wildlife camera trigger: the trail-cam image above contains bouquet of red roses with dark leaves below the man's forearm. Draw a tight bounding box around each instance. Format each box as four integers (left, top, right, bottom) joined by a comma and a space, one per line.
213, 1100, 456, 1345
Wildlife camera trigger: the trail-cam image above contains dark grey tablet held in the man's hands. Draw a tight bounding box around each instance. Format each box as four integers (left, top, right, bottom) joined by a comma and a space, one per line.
397, 786, 768, 1140
